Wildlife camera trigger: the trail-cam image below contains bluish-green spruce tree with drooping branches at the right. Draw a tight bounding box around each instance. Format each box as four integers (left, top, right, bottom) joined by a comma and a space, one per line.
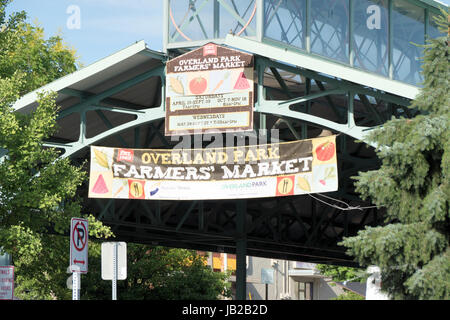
342, 11, 450, 299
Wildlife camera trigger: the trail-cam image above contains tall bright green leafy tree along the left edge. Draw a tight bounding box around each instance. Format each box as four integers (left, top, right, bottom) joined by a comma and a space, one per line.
0, 0, 111, 299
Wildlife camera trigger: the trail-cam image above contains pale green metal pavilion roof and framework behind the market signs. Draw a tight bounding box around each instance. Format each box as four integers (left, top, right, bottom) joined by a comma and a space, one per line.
11, 0, 446, 299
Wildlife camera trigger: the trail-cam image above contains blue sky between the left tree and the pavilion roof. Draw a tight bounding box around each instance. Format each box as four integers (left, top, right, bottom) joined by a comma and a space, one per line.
4, 0, 450, 65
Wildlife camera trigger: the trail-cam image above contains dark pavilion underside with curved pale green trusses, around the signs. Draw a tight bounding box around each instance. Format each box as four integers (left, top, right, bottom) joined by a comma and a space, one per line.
37, 50, 414, 265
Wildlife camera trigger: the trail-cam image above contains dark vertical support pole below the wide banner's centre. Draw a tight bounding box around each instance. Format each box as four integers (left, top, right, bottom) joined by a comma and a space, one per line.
236, 200, 247, 300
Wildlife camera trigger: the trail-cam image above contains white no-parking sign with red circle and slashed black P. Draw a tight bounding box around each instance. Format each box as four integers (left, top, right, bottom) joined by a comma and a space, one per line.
70, 218, 88, 273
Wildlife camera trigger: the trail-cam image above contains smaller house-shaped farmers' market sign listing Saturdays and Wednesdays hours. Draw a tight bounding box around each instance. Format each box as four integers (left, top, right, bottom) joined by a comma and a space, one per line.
165, 43, 254, 136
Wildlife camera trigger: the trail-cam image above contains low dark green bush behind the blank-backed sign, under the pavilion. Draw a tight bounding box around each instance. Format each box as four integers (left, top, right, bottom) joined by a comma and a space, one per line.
79, 243, 231, 300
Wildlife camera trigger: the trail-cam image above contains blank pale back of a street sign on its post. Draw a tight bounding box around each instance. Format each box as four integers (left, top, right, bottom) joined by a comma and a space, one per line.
102, 242, 127, 300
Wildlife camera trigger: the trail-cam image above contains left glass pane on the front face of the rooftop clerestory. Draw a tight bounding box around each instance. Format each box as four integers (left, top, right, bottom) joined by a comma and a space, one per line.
169, 0, 214, 42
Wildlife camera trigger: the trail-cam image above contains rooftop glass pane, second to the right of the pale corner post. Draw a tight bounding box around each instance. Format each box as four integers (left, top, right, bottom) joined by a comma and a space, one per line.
311, 0, 349, 63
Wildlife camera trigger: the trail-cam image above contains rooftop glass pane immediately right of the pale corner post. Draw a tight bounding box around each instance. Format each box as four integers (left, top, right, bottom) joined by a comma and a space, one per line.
264, 0, 306, 49
